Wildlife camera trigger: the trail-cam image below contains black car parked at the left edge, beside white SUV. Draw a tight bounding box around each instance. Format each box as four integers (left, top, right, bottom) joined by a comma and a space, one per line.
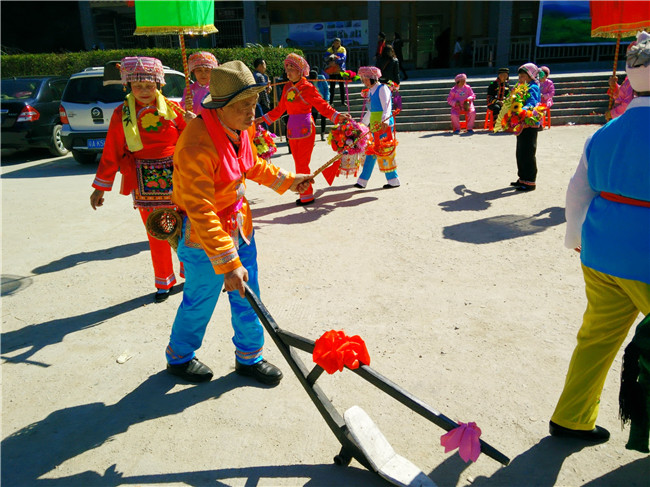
0, 76, 68, 156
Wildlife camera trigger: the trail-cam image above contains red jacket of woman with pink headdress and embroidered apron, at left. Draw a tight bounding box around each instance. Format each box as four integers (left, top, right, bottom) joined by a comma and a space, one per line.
92, 98, 185, 195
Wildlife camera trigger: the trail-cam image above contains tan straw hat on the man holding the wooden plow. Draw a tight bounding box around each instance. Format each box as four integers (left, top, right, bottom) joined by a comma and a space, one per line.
201, 61, 266, 108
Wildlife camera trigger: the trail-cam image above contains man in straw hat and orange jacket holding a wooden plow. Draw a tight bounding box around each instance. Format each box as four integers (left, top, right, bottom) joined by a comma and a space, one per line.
166, 61, 313, 385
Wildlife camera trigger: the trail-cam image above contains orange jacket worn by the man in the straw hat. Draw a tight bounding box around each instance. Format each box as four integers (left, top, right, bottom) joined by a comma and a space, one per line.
172, 118, 295, 274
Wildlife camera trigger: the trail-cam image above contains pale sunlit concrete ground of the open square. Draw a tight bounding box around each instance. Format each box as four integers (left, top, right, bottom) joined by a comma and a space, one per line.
1, 126, 650, 487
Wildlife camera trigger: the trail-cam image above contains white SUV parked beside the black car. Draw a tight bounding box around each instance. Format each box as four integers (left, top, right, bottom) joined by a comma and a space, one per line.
59, 66, 185, 164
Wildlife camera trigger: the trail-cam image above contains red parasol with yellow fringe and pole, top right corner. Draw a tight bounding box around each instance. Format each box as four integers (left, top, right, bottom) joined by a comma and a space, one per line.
589, 0, 650, 109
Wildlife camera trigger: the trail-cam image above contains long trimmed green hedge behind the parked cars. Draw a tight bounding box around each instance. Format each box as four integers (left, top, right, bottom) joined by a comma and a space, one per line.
0, 45, 303, 78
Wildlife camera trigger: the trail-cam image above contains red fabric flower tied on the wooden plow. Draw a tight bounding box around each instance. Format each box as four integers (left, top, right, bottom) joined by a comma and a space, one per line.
313, 330, 370, 374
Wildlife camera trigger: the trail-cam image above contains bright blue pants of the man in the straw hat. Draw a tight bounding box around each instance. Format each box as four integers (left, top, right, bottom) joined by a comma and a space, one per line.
165, 223, 264, 365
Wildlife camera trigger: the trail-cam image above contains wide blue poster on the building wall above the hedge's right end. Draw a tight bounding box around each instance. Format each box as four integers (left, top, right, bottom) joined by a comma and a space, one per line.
271, 20, 368, 48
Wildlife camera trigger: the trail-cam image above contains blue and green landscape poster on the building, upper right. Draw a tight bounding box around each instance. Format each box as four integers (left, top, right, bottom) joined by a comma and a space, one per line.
537, 0, 616, 46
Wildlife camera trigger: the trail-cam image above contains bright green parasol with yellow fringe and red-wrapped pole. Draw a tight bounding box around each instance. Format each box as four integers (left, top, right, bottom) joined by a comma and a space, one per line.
133, 0, 218, 110
